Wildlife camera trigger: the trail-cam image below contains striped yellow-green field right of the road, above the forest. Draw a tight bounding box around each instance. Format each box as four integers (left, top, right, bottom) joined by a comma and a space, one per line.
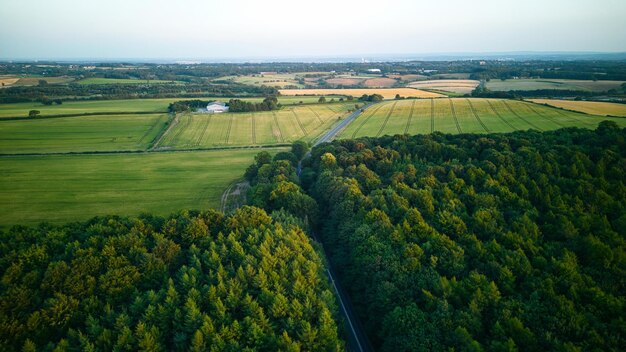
339, 98, 626, 139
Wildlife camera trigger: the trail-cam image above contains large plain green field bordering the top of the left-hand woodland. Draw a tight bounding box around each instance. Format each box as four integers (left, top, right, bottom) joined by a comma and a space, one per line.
0, 149, 281, 227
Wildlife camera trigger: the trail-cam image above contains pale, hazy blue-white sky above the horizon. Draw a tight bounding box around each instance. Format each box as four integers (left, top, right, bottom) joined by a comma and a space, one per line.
0, 0, 626, 59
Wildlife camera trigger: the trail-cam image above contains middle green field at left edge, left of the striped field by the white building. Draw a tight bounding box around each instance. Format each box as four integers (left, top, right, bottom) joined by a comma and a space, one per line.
0, 114, 169, 154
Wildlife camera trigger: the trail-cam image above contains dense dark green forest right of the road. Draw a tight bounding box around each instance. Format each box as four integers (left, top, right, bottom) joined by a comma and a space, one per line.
288, 122, 626, 351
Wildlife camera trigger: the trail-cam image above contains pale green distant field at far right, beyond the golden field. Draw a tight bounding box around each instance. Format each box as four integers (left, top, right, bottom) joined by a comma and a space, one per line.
486, 78, 624, 92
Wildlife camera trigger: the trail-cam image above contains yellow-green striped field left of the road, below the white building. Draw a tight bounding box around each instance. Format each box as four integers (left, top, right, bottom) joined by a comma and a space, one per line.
157, 102, 354, 149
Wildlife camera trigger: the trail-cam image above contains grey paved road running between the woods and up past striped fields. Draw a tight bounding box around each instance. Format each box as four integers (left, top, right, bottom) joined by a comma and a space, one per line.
297, 104, 374, 352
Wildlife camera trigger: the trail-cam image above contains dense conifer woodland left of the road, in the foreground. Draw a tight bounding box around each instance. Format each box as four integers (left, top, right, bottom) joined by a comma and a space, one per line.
0, 207, 344, 351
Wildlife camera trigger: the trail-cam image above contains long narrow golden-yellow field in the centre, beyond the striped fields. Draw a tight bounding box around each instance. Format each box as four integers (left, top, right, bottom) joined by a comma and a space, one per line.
279, 88, 444, 99
